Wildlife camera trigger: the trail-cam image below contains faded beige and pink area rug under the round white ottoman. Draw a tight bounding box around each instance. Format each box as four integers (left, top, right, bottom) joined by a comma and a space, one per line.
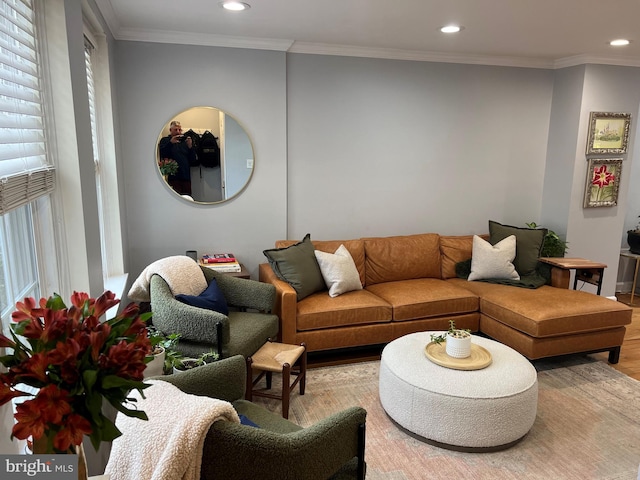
254, 355, 640, 480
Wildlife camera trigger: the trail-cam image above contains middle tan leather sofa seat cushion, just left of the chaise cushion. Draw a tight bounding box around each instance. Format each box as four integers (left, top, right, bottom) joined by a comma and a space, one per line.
366, 278, 478, 322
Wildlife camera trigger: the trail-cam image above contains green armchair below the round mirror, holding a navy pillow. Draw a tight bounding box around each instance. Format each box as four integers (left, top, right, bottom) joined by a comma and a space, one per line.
150, 267, 279, 358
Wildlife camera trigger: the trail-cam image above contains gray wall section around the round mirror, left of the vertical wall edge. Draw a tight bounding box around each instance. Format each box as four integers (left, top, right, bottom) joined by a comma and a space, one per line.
115, 42, 287, 282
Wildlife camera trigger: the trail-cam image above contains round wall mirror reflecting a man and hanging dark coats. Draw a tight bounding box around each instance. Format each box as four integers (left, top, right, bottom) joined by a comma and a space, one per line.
156, 107, 254, 204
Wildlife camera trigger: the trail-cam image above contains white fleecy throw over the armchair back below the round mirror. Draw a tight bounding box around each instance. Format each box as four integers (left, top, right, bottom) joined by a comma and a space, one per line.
127, 255, 207, 302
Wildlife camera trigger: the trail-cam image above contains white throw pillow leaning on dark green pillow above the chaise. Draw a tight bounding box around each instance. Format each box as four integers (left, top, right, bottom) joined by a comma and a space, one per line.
468, 235, 520, 282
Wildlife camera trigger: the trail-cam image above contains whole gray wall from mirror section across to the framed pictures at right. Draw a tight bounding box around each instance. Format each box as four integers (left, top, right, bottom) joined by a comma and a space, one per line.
115, 41, 640, 295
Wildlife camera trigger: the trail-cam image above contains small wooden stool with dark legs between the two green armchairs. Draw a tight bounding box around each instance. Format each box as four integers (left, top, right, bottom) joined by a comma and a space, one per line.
245, 342, 307, 418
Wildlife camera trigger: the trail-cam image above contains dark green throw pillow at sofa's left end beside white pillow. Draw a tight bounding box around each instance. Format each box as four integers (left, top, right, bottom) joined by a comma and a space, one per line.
262, 233, 327, 301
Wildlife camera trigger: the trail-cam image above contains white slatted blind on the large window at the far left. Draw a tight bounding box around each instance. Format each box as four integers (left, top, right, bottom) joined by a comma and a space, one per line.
0, 0, 55, 214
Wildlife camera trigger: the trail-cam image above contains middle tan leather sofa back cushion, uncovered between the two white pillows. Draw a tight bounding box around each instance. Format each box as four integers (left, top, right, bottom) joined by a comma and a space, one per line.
364, 233, 440, 285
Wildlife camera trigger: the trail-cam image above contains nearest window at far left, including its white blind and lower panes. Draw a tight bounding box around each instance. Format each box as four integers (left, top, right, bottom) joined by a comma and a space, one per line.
0, 0, 55, 336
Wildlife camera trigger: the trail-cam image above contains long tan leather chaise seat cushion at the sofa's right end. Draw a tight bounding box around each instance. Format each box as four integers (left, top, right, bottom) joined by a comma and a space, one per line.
447, 279, 632, 338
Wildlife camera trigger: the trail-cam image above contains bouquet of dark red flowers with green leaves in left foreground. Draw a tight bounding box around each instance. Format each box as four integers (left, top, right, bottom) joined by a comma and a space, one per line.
0, 291, 151, 453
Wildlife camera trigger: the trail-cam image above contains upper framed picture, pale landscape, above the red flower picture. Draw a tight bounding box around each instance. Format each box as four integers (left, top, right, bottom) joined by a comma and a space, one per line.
587, 112, 631, 155
